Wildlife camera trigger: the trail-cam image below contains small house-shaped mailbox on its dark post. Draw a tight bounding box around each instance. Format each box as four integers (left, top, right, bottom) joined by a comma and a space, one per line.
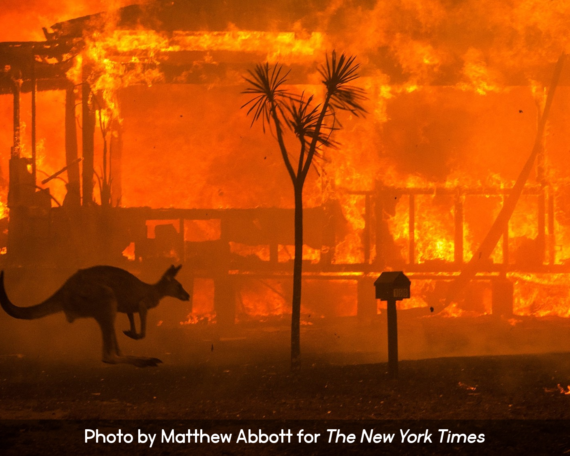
374, 271, 411, 378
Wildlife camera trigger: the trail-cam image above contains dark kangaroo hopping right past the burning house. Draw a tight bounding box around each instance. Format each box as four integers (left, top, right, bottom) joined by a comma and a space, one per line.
0, 265, 190, 367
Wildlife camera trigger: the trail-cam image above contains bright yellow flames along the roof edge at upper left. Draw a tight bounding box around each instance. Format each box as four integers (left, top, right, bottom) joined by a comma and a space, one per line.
67, 28, 324, 125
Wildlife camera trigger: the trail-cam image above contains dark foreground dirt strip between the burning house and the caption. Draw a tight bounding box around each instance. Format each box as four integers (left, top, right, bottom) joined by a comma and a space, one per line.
0, 353, 570, 420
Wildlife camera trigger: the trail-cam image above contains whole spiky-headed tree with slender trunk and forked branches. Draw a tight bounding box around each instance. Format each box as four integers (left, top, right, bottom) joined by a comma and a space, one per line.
242, 52, 366, 369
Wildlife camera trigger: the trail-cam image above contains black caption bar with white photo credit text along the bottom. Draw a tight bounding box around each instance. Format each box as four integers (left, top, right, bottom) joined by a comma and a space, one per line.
0, 420, 570, 455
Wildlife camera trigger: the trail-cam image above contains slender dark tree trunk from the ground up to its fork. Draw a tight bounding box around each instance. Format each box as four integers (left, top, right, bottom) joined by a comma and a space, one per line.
291, 181, 303, 369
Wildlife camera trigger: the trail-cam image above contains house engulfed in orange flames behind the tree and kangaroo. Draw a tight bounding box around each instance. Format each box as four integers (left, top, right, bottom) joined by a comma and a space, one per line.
0, 0, 570, 334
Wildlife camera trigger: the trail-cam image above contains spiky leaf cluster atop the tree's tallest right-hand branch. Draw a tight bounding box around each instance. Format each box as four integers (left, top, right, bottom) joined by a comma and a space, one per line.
319, 51, 367, 116
